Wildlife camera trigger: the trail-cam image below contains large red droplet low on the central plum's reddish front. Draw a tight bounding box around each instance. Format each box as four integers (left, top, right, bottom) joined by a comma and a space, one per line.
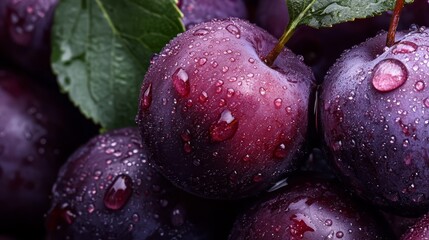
210, 109, 238, 142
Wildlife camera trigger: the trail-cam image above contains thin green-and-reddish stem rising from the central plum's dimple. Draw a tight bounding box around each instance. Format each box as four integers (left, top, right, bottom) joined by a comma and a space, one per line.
263, 0, 316, 67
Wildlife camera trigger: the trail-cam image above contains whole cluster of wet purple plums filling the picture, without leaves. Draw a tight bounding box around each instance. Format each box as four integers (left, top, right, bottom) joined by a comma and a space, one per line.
0, 0, 429, 240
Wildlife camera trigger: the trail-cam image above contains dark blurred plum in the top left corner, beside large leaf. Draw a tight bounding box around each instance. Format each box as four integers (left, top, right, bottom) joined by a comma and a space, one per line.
0, 0, 58, 76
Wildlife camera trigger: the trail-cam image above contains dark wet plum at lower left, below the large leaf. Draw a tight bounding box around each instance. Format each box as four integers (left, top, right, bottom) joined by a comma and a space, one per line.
47, 128, 232, 240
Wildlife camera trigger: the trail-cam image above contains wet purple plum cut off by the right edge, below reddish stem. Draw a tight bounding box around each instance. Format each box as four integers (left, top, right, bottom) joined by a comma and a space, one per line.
319, 28, 429, 215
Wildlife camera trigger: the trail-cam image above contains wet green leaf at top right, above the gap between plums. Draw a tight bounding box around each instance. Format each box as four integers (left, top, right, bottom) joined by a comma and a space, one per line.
287, 0, 413, 28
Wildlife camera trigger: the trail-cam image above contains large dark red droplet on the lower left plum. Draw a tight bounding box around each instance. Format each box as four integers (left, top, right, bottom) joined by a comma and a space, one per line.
103, 174, 133, 210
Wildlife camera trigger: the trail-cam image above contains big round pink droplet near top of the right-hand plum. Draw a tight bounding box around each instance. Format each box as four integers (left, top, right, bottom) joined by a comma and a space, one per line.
372, 58, 408, 92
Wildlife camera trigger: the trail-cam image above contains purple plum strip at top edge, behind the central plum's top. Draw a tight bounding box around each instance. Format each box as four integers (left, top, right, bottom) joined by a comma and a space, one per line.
178, 0, 247, 29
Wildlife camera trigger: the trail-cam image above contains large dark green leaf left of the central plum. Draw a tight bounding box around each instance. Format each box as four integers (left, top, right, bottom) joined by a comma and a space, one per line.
52, 0, 184, 129
